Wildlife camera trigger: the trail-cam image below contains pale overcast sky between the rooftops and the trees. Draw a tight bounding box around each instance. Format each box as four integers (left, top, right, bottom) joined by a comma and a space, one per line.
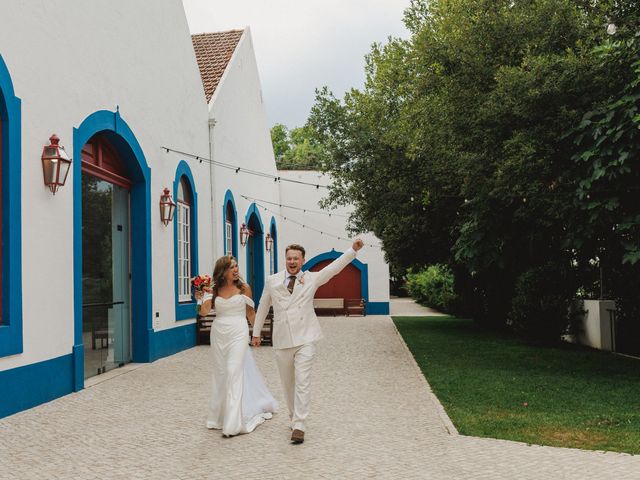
183, 0, 410, 128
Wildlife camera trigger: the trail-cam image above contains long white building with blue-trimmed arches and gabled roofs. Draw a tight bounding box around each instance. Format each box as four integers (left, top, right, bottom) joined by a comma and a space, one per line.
0, 0, 389, 417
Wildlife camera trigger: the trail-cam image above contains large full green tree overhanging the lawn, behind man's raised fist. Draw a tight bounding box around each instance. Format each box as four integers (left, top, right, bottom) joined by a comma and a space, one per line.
308, 0, 614, 335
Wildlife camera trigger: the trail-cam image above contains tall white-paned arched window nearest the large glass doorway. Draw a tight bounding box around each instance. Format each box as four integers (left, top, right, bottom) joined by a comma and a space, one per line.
176, 177, 193, 302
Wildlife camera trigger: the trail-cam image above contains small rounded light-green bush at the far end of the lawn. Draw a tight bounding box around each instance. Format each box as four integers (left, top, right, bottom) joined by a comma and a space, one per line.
406, 265, 457, 312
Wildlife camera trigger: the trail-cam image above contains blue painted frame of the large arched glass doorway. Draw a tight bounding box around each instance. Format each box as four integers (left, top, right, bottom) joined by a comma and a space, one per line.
72, 110, 153, 390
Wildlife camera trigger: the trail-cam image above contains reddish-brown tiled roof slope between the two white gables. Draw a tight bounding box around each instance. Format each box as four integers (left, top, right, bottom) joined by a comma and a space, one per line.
191, 30, 244, 103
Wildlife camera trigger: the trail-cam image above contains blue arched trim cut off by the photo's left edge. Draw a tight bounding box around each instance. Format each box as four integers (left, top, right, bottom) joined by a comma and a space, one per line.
0, 55, 23, 358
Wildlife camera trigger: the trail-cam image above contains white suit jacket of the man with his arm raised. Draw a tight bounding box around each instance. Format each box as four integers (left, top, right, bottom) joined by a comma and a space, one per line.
253, 248, 356, 349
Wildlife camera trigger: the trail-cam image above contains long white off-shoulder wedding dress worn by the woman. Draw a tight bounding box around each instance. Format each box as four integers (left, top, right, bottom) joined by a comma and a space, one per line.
207, 294, 278, 436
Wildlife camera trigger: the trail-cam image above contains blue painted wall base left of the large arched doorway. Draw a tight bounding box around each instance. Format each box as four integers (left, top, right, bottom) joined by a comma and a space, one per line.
0, 354, 74, 418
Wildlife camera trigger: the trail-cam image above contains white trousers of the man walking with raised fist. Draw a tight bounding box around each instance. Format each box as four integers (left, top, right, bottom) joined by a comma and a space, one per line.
274, 343, 316, 432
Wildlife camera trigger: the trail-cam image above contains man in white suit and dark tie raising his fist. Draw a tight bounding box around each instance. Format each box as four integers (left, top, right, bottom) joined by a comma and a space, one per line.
251, 239, 364, 443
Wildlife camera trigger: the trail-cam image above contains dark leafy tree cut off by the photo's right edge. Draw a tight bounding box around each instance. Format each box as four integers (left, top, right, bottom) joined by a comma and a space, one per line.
570, 15, 640, 354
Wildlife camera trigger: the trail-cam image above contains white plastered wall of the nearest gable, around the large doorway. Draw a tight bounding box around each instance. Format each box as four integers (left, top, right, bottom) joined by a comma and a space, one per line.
0, 0, 211, 370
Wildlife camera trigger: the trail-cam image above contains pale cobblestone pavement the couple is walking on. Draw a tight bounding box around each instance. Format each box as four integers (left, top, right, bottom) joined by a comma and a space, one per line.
0, 310, 640, 480
